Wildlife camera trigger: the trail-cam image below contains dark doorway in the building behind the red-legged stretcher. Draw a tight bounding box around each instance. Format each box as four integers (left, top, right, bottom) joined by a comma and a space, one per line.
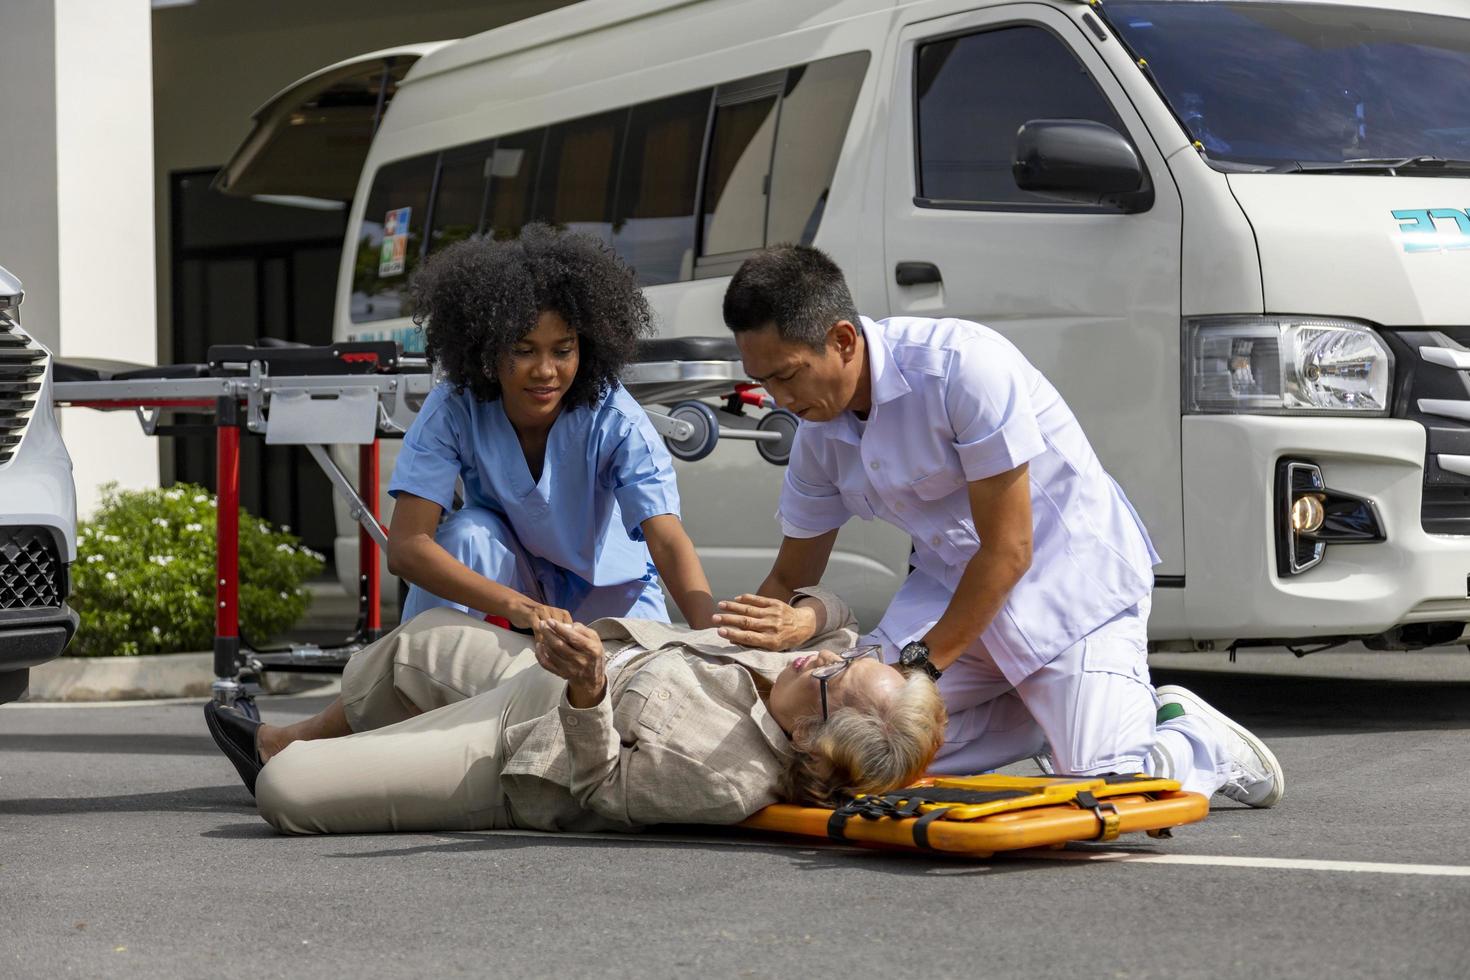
169, 169, 347, 563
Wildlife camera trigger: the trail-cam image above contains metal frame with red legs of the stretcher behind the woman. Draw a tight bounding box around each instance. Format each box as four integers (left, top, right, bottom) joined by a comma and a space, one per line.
51, 344, 789, 714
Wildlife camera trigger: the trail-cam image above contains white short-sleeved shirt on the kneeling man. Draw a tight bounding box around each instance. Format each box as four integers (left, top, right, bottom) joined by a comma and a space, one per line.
778, 317, 1158, 683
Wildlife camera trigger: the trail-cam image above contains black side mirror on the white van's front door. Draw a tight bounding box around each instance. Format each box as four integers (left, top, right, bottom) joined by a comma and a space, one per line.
1011, 119, 1154, 213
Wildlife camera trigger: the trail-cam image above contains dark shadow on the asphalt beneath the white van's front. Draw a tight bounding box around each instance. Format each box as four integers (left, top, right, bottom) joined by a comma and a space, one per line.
1150, 667, 1470, 735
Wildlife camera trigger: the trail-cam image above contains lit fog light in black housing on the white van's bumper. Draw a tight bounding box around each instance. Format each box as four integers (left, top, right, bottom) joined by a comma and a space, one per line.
1276, 460, 1385, 577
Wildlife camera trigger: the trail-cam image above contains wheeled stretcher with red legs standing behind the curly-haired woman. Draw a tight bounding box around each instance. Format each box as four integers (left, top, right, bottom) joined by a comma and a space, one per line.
53, 338, 795, 714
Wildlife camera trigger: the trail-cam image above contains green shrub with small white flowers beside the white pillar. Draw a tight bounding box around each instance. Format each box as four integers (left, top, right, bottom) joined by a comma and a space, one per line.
66, 483, 323, 657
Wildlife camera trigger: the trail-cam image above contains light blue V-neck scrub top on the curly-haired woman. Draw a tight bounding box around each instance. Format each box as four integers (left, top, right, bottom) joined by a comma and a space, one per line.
388, 382, 679, 586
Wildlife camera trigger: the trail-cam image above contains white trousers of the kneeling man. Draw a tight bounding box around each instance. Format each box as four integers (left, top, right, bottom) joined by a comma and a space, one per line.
885, 598, 1230, 796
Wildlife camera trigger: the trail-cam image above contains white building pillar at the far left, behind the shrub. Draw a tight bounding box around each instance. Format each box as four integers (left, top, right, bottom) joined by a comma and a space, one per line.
0, 0, 159, 516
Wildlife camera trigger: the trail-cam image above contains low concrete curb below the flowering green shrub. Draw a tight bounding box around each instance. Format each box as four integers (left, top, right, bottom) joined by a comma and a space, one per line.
28, 652, 337, 701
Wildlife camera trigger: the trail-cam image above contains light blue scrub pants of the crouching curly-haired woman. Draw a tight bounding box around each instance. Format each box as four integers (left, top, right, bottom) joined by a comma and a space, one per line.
403, 507, 669, 623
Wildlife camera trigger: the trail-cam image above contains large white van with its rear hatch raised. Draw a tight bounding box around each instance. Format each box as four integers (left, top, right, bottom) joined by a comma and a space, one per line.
221, 0, 1470, 649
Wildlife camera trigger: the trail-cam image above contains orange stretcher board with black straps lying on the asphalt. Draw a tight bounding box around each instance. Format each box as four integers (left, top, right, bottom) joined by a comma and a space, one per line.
741, 776, 1210, 858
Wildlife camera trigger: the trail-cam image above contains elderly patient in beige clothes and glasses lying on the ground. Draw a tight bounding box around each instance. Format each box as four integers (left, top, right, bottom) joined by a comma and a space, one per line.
204, 589, 945, 833
